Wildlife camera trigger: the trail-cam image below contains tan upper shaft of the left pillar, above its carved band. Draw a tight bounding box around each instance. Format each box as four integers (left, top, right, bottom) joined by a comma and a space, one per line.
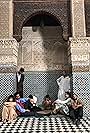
0, 0, 13, 39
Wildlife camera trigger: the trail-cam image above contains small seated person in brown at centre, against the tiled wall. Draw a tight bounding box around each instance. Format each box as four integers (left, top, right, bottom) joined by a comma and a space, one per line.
42, 95, 52, 110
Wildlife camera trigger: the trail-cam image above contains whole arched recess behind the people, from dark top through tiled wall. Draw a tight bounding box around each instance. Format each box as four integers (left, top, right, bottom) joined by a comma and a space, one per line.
18, 12, 70, 103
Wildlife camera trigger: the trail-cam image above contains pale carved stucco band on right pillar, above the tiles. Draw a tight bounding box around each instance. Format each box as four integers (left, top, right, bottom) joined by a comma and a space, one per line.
69, 37, 90, 72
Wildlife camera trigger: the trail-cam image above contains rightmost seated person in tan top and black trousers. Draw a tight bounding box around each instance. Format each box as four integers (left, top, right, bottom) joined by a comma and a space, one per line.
69, 95, 83, 125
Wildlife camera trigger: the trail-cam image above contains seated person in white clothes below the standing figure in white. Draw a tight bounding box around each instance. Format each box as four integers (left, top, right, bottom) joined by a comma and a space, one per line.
53, 92, 72, 115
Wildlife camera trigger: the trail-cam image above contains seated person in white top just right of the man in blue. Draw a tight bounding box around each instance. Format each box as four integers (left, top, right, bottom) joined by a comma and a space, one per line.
25, 95, 41, 112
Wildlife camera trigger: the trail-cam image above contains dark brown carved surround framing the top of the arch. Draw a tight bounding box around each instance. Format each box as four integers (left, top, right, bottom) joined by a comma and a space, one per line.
13, 0, 71, 41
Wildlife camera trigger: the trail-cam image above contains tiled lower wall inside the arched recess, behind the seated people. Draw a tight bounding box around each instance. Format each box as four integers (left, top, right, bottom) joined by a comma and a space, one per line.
24, 71, 61, 104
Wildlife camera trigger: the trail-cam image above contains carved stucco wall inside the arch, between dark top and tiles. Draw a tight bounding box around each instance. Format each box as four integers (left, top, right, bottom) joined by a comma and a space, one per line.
18, 27, 68, 71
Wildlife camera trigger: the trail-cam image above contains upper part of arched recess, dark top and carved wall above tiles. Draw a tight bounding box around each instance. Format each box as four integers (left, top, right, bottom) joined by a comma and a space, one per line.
18, 12, 68, 71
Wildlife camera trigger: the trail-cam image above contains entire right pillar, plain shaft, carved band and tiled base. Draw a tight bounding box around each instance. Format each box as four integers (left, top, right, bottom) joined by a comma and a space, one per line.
69, 0, 90, 116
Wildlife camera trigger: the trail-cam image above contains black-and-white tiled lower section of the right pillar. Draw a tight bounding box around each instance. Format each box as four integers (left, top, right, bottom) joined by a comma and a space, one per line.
73, 72, 90, 116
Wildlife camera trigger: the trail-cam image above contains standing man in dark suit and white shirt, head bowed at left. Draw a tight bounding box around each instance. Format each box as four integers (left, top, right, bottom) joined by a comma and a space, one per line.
16, 67, 24, 97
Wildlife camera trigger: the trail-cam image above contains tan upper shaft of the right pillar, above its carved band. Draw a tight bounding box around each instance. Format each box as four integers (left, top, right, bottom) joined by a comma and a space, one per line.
71, 0, 86, 37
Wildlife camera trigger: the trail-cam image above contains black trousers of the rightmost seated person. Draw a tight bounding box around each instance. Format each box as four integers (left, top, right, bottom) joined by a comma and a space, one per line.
69, 107, 83, 120
